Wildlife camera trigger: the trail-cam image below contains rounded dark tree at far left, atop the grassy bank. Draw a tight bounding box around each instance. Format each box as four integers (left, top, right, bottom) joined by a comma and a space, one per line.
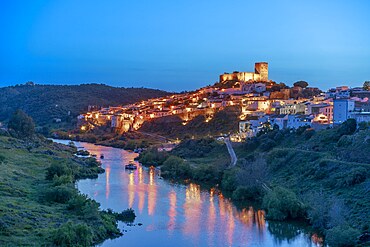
8, 110, 35, 138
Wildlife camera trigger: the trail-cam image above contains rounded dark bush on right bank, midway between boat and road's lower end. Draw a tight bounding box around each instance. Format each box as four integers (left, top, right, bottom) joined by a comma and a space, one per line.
161, 156, 191, 178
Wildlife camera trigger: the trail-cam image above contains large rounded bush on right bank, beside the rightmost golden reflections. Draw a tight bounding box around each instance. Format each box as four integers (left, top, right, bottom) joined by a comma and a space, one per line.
262, 187, 304, 220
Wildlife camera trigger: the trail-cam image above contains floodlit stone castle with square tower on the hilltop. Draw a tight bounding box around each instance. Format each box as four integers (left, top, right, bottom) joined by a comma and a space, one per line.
220, 62, 269, 82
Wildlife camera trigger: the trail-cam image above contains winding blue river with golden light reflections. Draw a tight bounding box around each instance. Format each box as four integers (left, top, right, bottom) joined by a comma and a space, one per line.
54, 140, 320, 247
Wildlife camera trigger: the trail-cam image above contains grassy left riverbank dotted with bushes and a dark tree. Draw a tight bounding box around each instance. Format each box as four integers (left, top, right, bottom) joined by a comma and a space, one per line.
0, 111, 135, 246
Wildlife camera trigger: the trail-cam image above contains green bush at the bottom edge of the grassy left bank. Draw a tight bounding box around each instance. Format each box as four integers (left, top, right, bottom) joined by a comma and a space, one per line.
52, 222, 93, 246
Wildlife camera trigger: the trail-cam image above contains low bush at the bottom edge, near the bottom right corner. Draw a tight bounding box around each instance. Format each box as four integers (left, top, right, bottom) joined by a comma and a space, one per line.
326, 226, 360, 247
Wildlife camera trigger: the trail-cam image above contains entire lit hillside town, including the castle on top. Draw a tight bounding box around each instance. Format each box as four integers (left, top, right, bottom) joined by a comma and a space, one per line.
78, 62, 370, 141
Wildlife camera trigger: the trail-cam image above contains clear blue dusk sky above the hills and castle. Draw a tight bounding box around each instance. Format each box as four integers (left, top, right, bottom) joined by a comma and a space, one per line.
0, 0, 370, 91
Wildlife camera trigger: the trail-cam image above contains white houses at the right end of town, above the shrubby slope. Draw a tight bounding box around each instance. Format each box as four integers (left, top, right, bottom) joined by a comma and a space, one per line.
234, 86, 370, 139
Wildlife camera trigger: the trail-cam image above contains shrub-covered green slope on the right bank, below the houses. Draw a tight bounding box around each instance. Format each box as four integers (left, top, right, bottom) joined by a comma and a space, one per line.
139, 119, 370, 246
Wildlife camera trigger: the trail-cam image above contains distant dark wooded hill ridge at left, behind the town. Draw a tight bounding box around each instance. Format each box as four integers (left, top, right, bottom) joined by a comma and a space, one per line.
0, 83, 170, 127
